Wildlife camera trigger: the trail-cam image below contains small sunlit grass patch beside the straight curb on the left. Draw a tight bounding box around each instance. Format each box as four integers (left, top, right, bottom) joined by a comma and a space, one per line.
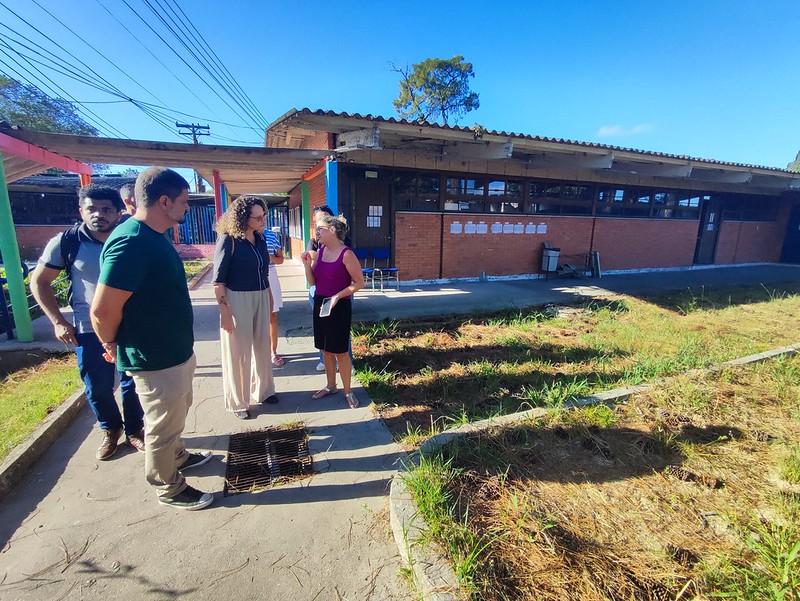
0, 355, 80, 460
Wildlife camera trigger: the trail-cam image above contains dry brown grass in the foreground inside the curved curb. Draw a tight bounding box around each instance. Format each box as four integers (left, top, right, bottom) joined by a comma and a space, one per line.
409, 357, 800, 600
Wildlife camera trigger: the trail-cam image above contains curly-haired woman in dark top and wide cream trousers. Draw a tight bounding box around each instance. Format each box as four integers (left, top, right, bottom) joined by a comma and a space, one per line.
213, 196, 278, 419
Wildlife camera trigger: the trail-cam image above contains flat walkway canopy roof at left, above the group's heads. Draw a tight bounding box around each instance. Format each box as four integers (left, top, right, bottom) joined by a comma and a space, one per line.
3, 129, 330, 194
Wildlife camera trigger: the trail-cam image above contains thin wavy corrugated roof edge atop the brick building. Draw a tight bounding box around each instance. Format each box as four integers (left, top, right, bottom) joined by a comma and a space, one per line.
268, 108, 794, 173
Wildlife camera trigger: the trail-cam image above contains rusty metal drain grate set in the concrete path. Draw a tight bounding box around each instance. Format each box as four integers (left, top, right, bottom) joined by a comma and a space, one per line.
224, 427, 313, 496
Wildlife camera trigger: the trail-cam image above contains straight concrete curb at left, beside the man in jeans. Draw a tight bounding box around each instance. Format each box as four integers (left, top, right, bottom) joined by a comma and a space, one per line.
0, 390, 86, 500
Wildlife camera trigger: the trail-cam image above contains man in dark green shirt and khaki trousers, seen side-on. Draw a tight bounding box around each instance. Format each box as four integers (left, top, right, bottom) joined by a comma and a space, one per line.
91, 167, 214, 510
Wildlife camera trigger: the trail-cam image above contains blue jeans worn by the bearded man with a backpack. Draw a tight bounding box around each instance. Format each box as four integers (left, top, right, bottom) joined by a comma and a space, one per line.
75, 332, 144, 436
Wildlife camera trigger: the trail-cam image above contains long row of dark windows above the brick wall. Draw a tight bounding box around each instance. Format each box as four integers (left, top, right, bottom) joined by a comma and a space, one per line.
392, 173, 777, 221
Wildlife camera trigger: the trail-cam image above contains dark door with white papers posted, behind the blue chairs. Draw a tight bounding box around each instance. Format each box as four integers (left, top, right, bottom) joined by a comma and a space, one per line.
352, 179, 392, 248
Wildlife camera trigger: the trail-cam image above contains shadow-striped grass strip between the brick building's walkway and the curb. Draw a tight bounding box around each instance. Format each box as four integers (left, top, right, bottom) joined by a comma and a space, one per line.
354, 283, 800, 446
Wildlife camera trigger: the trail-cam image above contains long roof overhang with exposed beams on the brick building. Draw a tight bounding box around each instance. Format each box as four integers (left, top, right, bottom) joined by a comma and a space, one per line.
266, 109, 800, 194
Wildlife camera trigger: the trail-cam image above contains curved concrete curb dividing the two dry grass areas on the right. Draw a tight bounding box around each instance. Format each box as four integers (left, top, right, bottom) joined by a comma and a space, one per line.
389, 343, 800, 601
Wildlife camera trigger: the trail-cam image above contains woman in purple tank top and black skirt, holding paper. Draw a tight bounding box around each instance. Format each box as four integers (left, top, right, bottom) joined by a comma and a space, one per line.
302, 212, 364, 408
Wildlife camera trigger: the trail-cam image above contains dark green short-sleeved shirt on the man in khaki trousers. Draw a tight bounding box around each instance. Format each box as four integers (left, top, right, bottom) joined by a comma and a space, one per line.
99, 218, 194, 371
